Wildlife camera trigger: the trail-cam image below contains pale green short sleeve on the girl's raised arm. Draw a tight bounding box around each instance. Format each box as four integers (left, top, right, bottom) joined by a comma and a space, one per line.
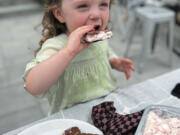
23, 35, 64, 97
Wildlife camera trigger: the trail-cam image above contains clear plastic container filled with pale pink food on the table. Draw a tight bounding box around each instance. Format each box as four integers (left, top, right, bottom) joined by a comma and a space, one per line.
135, 105, 180, 135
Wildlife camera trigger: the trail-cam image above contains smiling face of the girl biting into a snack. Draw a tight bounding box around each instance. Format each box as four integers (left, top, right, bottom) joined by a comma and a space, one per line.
56, 0, 110, 33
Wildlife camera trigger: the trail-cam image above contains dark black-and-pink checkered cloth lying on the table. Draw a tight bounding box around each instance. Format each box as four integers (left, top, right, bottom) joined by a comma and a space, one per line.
91, 102, 144, 135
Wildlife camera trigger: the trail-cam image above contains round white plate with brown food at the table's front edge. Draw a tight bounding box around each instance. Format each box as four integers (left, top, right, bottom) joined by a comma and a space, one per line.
18, 119, 103, 135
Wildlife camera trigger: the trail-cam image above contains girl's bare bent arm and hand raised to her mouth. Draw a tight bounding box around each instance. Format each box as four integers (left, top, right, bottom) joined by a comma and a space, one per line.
25, 26, 93, 95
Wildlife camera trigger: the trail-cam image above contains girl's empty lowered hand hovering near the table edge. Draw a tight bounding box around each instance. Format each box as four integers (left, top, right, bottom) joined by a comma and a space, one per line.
110, 58, 135, 80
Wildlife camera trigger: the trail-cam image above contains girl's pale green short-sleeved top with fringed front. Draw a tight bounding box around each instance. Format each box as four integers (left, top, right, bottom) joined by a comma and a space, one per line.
23, 34, 117, 114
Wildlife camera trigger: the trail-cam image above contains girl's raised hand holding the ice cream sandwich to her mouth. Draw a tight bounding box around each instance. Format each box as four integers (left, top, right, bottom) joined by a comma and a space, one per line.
65, 25, 94, 56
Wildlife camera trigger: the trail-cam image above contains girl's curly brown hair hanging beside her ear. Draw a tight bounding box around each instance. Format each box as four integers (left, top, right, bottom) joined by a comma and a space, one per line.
35, 0, 113, 54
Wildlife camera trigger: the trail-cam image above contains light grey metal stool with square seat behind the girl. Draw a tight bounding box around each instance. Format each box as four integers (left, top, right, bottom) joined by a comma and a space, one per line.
124, 6, 175, 73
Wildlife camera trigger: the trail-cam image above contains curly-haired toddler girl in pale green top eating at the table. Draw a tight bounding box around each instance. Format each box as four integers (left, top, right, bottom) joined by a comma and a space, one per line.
24, 0, 134, 114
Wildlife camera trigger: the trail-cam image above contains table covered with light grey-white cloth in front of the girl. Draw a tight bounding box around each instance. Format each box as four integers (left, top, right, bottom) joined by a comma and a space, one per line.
4, 68, 180, 135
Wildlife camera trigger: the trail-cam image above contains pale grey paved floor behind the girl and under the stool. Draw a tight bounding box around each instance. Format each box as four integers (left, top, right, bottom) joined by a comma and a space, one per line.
0, 2, 180, 134
